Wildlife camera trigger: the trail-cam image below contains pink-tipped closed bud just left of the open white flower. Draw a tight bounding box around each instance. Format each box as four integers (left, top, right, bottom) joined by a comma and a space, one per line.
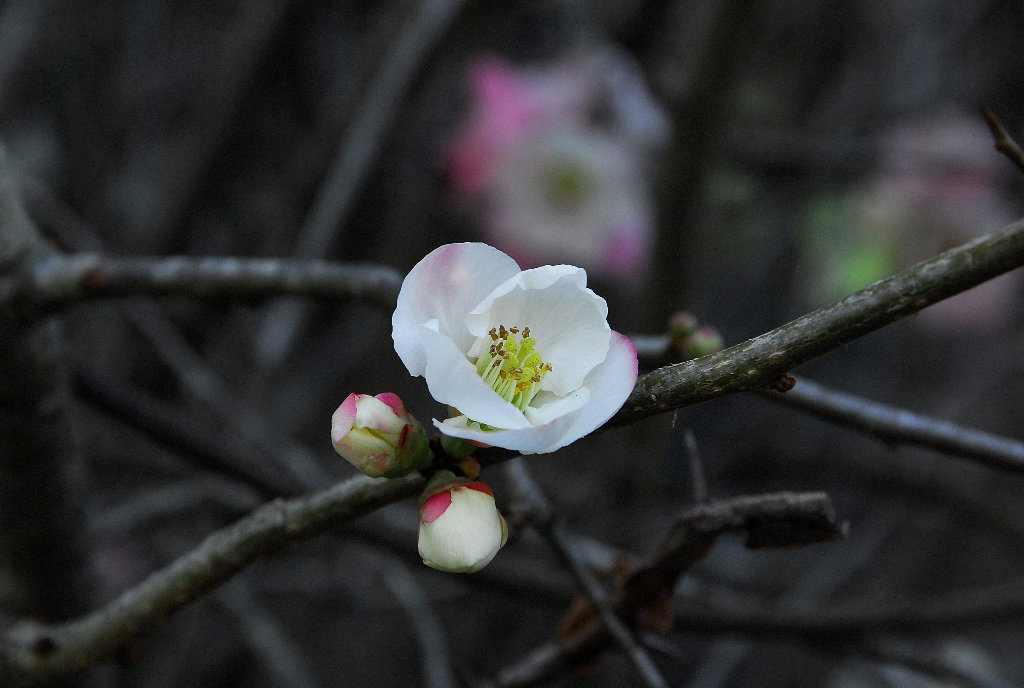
331, 392, 431, 478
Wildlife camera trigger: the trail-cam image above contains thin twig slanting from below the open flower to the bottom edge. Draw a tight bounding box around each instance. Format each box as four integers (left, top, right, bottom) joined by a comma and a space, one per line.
506, 458, 669, 688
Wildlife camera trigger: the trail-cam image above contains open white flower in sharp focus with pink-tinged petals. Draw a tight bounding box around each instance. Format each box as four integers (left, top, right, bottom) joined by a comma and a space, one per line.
392, 244, 637, 454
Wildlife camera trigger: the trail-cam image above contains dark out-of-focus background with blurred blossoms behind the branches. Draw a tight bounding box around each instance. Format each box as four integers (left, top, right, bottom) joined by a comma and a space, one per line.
0, 0, 1024, 688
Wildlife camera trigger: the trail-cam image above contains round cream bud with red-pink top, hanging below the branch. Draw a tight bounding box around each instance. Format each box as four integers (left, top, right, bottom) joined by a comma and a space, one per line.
419, 479, 508, 573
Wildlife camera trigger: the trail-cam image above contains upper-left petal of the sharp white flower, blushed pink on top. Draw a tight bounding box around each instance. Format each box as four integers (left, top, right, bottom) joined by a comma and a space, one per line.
391, 244, 519, 375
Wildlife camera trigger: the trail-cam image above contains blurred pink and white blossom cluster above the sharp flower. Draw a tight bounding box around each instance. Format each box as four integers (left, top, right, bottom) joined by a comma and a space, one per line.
446, 51, 669, 280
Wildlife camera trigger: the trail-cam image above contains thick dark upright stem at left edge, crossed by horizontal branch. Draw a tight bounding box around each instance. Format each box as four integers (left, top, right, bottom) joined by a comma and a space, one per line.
0, 147, 95, 618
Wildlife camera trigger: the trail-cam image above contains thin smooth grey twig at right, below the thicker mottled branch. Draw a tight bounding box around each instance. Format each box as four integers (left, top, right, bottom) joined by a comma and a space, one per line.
764, 378, 1024, 473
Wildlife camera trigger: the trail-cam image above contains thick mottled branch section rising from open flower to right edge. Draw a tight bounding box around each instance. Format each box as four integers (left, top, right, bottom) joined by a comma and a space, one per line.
608, 220, 1024, 425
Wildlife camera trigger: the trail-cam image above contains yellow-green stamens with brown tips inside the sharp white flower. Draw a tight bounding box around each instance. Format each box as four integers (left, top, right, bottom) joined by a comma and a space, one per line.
476, 325, 551, 413
